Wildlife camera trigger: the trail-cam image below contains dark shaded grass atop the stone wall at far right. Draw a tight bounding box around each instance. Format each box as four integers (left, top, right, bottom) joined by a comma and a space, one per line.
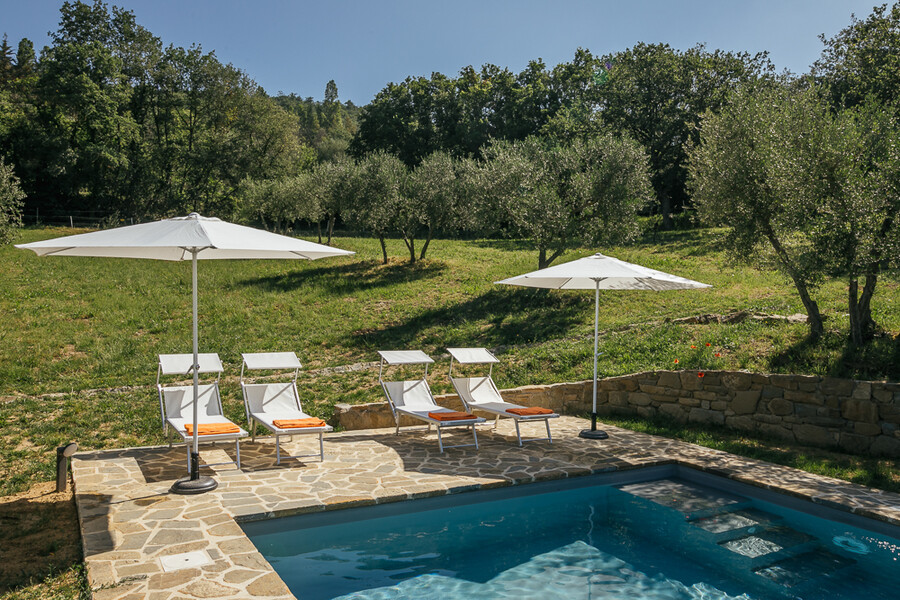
769, 331, 900, 380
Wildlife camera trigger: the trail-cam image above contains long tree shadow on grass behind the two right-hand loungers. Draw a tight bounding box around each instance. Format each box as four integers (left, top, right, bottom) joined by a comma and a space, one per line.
347, 289, 589, 348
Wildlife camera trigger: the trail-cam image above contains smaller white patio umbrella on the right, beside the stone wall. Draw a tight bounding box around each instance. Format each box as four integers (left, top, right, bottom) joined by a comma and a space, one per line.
495, 253, 712, 439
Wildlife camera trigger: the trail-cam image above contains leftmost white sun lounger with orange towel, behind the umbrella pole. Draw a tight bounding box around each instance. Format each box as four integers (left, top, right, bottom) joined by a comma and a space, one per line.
156, 353, 247, 469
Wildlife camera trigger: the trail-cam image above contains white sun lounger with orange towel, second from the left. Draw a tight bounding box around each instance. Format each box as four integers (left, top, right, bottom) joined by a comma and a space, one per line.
241, 352, 332, 465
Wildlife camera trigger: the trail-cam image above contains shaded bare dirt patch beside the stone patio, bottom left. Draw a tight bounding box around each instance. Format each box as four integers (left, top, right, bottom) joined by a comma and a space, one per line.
0, 482, 81, 593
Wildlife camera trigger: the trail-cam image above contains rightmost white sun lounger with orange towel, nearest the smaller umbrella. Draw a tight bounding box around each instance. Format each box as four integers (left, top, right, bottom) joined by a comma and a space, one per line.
447, 348, 559, 446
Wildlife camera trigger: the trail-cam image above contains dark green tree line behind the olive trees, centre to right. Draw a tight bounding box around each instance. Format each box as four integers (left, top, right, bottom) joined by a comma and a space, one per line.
350, 43, 772, 227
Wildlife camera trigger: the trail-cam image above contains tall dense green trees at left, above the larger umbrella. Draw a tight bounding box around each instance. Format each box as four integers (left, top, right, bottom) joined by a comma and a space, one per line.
0, 1, 354, 218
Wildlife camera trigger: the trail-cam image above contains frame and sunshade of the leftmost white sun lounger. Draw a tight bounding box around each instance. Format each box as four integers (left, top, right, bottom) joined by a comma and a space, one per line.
156, 352, 247, 470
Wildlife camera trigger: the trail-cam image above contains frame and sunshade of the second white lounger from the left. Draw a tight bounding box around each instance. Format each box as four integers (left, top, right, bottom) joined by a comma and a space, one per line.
241, 352, 333, 465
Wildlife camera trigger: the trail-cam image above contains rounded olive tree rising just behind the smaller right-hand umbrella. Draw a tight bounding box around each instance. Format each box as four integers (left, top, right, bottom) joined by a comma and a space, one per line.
469, 134, 653, 269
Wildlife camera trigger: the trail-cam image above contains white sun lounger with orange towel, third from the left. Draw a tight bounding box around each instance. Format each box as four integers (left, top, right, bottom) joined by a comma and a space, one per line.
378, 350, 484, 452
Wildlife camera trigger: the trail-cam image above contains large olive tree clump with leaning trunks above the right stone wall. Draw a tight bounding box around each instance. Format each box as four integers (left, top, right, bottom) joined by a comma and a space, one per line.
689, 86, 900, 343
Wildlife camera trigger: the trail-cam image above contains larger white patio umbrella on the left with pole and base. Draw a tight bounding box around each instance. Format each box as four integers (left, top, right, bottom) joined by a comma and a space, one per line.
16, 213, 354, 494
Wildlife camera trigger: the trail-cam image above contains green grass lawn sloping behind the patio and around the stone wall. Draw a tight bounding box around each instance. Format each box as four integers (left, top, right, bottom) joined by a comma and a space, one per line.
0, 223, 900, 600
